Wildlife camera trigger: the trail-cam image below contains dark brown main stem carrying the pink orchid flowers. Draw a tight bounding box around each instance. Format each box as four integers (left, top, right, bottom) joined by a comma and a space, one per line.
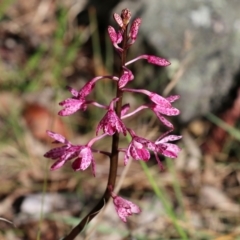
62, 27, 128, 240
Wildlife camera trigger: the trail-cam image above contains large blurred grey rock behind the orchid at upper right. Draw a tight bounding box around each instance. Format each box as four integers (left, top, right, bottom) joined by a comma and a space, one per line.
117, 0, 240, 122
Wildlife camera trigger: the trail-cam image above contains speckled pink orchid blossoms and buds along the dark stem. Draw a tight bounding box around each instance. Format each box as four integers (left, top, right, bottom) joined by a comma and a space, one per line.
44, 8, 181, 222
